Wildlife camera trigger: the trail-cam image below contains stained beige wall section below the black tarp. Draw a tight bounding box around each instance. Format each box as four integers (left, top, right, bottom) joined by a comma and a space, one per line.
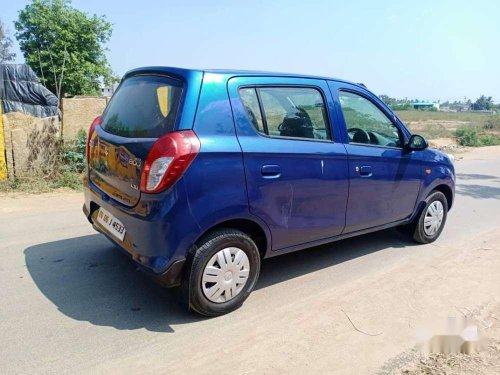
2, 112, 61, 178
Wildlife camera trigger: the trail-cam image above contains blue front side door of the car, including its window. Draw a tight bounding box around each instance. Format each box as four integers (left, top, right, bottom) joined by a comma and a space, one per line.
329, 82, 423, 233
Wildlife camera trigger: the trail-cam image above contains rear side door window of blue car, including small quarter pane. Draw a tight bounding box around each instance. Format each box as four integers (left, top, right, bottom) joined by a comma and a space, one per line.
240, 87, 332, 140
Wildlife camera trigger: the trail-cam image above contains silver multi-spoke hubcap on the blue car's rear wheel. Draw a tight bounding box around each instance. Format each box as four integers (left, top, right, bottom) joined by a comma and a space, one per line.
201, 247, 250, 303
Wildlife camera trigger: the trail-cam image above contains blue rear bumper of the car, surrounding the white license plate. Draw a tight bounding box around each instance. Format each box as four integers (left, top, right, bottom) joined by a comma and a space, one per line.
83, 178, 194, 287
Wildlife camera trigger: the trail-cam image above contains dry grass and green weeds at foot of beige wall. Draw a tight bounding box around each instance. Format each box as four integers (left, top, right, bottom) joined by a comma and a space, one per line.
0, 130, 87, 194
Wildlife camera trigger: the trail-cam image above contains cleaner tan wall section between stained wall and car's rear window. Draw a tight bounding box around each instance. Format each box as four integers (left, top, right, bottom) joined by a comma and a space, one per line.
61, 96, 108, 139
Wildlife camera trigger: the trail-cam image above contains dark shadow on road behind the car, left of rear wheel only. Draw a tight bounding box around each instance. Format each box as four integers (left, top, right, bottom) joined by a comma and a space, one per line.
24, 234, 197, 332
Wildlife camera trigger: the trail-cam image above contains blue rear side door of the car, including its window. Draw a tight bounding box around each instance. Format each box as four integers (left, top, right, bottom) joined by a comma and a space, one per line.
229, 77, 348, 250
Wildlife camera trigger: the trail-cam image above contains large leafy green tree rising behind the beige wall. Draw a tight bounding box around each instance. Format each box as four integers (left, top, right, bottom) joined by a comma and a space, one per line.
15, 0, 116, 99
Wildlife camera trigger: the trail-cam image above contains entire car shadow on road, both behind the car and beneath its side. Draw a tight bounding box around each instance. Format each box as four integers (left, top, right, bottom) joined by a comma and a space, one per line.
24, 230, 418, 332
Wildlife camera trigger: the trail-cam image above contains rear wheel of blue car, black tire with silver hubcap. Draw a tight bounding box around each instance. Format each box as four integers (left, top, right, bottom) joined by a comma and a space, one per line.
183, 229, 260, 317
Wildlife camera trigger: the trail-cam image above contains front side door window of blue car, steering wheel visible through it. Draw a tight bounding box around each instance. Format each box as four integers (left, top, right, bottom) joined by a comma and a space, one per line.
339, 91, 402, 147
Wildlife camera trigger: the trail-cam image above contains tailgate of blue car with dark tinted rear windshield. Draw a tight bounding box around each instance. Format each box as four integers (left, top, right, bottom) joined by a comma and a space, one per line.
89, 74, 182, 206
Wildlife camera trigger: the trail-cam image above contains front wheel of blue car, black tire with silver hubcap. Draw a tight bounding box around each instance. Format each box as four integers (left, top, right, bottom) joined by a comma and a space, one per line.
398, 190, 448, 244
